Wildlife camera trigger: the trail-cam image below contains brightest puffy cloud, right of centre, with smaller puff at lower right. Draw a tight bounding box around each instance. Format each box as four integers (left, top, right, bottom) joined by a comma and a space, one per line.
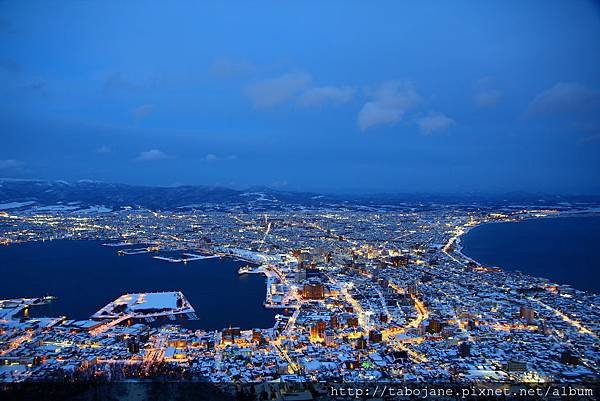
358, 81, 422, 131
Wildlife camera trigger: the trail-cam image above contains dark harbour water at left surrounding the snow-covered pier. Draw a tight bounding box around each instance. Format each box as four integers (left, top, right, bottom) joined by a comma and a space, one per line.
0, 240, 277, 330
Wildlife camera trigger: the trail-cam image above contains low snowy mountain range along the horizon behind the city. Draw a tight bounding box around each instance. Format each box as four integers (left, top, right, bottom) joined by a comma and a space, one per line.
0, 179, 600, 210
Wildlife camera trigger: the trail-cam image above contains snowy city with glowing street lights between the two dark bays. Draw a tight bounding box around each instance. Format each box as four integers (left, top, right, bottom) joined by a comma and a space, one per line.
0, 199, 600, 383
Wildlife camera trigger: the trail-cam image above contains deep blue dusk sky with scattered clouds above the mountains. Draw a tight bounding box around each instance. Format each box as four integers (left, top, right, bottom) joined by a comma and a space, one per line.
0, 0, 600, 193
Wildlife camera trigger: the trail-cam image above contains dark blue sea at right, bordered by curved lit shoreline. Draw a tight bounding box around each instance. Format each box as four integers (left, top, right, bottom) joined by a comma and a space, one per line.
461, 216, 600, 293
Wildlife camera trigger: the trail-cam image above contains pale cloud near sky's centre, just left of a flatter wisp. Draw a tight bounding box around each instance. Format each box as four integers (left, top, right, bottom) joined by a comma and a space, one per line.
243, 72, 312, 109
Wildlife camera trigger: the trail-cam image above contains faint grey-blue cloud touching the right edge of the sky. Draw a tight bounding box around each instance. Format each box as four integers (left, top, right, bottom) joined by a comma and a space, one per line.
527, 82, 600, 115
